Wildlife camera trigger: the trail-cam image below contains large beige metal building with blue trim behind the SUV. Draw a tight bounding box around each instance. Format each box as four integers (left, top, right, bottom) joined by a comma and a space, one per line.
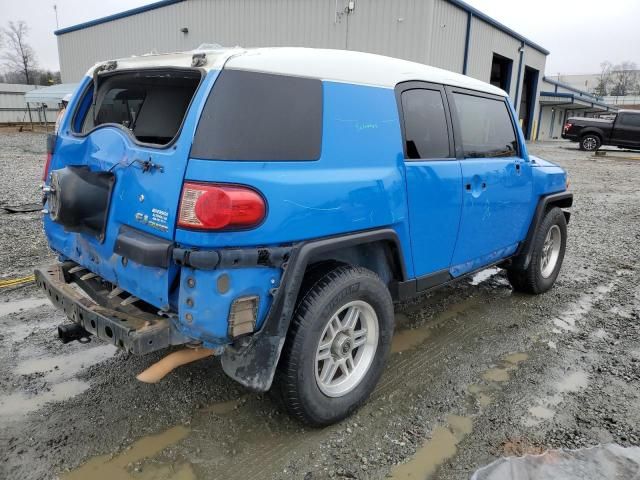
55, 0, 549, 138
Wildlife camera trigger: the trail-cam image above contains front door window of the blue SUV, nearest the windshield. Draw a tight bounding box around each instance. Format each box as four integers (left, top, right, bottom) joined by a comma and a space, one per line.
453, 93, 518, 158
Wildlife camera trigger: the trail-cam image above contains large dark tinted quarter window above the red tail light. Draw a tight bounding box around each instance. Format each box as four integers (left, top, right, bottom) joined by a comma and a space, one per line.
191, 70, 322, 161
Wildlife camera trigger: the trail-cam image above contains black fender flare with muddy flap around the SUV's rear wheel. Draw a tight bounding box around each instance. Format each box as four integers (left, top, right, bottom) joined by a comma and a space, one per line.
221, 228, 406, 392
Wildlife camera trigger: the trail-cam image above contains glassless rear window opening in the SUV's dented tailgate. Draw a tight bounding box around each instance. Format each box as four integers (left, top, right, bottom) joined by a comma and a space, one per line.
74, 68, 202, 146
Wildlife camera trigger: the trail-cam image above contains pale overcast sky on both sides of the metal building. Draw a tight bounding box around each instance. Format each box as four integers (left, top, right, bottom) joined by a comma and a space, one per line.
0, 0, 640, 74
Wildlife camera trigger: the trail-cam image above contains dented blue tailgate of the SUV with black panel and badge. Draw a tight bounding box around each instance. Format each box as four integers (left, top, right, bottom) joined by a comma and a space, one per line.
45, 66, 206, 310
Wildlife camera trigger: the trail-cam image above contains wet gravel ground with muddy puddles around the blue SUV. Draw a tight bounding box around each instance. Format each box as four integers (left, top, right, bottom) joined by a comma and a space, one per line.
0, 133, 640, 480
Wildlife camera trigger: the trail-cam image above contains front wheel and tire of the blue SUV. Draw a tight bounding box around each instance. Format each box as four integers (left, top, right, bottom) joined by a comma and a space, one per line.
507, 207, 567, 295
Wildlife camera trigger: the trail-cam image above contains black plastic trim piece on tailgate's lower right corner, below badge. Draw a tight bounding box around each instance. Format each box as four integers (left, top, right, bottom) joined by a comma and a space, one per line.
113, 225, 173, 268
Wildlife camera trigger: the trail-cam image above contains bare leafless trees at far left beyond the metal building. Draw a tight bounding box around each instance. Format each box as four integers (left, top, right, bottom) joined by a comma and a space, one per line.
0, 20, 60, 85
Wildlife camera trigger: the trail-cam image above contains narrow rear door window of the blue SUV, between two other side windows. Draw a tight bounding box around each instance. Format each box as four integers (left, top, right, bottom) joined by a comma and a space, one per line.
402, 88, 451, 158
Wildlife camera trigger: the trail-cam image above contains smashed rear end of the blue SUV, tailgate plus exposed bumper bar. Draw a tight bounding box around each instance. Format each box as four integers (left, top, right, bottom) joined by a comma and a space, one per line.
36, 51, 272, 360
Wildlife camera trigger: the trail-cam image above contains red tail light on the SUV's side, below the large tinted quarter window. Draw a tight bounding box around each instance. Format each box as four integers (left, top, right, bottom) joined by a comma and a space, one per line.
178, 182, 266, 230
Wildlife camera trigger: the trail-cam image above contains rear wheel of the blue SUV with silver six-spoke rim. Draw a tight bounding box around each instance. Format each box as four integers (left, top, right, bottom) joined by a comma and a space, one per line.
277, 265, 394, 427
